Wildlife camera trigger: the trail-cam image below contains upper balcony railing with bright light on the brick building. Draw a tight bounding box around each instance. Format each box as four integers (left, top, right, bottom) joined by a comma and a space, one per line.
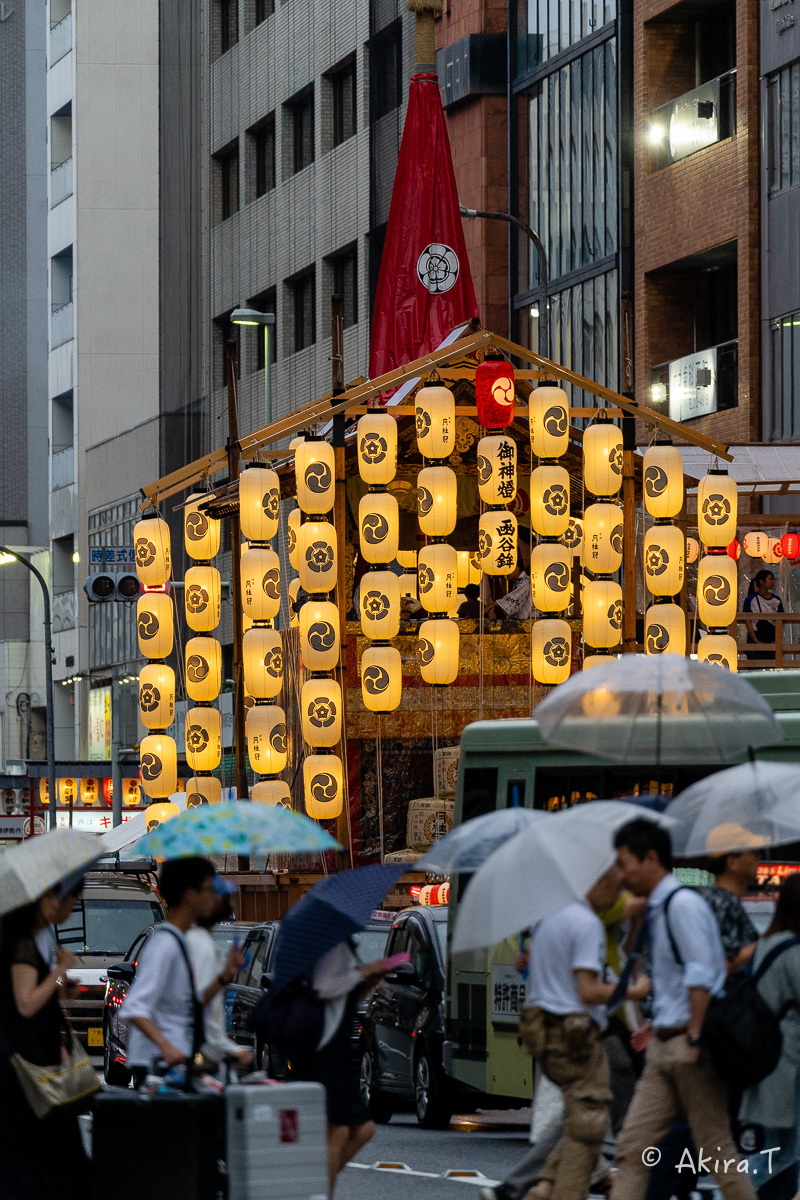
646, 70, 736, 170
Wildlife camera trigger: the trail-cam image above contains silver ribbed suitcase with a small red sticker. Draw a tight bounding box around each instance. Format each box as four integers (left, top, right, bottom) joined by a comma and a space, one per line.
225, 1084, 327, 1200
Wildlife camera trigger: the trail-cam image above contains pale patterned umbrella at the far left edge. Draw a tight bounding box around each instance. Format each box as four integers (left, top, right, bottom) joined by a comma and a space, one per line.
0, 829, 102, 916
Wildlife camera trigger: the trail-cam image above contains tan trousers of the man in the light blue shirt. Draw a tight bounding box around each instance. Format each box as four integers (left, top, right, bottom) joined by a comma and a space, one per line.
612, 1034, 756, 1200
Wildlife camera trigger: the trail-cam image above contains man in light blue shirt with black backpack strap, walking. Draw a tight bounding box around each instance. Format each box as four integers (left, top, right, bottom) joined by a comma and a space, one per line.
612, 818, 754, 1200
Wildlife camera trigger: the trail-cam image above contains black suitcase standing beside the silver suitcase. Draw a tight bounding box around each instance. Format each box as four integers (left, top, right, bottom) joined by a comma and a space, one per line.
91, 1090, 225, 1200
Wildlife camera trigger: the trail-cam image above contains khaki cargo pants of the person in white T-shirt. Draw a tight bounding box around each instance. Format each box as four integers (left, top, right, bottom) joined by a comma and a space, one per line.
539, 1014, 610, 1200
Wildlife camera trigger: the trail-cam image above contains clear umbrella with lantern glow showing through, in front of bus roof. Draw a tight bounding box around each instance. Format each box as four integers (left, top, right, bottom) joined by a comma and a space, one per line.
534, 654, 783, 764
